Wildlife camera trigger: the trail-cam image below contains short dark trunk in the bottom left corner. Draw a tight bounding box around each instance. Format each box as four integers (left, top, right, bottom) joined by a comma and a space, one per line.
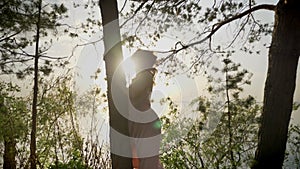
3, 136, 17, 169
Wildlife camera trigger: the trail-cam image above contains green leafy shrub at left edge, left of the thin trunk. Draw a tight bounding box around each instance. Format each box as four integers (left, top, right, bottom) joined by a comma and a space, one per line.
0, 81, 29, 168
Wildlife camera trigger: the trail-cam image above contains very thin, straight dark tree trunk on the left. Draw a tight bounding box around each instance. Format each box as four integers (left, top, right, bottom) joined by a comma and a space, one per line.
30, 0, 42, 169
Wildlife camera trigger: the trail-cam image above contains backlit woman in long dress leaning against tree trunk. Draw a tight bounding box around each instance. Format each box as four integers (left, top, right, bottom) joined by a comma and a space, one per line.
129, 50, 162, 169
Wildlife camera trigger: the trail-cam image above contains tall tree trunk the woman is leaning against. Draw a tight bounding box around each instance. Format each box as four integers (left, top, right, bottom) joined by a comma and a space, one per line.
99, 0, 132, 169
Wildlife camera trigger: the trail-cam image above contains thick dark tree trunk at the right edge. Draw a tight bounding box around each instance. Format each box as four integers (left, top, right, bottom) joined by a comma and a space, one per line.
252, 0, 300, 169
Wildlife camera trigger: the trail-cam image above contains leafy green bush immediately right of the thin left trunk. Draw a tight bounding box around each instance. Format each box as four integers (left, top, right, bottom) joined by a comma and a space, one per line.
37, 76, 83, 166
